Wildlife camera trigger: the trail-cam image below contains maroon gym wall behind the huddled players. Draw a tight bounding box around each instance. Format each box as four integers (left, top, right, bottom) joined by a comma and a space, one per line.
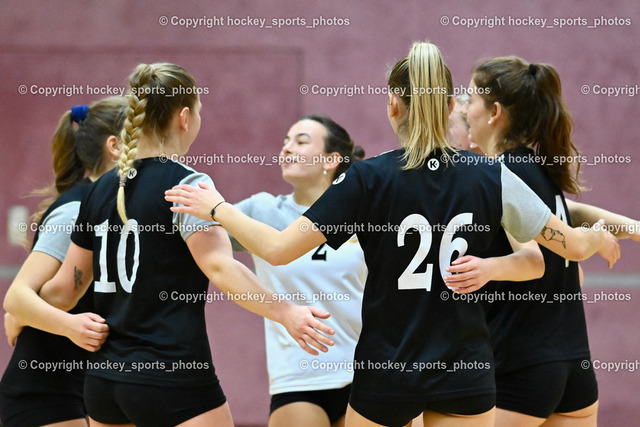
0, 0, 640, 425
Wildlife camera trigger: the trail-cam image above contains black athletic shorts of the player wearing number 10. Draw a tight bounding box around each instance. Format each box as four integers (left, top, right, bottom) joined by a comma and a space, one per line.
84, 375, 227, 427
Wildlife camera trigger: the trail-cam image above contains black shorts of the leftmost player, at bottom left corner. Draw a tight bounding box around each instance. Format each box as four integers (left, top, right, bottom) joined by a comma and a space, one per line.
0, 393, 87, 427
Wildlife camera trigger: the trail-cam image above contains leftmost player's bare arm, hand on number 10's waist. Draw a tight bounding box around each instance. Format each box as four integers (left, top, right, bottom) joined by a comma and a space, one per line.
4, 251, 109, 351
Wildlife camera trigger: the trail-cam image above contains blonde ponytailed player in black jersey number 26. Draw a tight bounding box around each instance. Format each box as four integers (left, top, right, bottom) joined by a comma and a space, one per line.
167, 43, 619, 426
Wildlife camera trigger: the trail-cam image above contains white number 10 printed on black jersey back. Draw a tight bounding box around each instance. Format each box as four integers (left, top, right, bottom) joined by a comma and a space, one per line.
94, 218, 140, 293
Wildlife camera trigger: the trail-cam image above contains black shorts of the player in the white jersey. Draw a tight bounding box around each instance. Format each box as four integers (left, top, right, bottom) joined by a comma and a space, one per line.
270, 384, 351, 424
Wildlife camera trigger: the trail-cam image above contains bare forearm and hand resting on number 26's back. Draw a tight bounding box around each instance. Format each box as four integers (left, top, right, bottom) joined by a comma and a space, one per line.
444, 233, 544, 294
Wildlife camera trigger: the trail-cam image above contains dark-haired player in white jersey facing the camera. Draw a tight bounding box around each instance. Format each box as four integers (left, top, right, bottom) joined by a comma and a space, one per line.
232, 115, 367, 427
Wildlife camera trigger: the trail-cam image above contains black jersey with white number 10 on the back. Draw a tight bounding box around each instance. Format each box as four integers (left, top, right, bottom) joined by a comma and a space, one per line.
71, 158, 217, 386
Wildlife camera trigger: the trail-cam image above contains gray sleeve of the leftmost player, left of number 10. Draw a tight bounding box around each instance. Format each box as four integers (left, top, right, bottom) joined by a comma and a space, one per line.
33, 202, 80, 262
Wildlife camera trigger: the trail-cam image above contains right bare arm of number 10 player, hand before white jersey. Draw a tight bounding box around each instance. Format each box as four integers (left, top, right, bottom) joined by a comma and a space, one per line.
186, 226, 334, 355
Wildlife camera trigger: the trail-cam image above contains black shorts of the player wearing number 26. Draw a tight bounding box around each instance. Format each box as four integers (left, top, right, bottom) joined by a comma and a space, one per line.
349, 393, 496, 427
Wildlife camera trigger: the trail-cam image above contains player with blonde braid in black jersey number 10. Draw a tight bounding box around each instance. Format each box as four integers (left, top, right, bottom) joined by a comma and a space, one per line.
33, 63, 333, 427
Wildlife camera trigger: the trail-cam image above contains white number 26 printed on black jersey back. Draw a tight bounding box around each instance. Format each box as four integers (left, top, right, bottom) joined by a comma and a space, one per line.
398, 212, 473, 292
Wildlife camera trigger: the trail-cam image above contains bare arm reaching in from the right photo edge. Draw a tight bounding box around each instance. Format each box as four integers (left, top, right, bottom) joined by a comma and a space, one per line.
566, 199, 640, 242
